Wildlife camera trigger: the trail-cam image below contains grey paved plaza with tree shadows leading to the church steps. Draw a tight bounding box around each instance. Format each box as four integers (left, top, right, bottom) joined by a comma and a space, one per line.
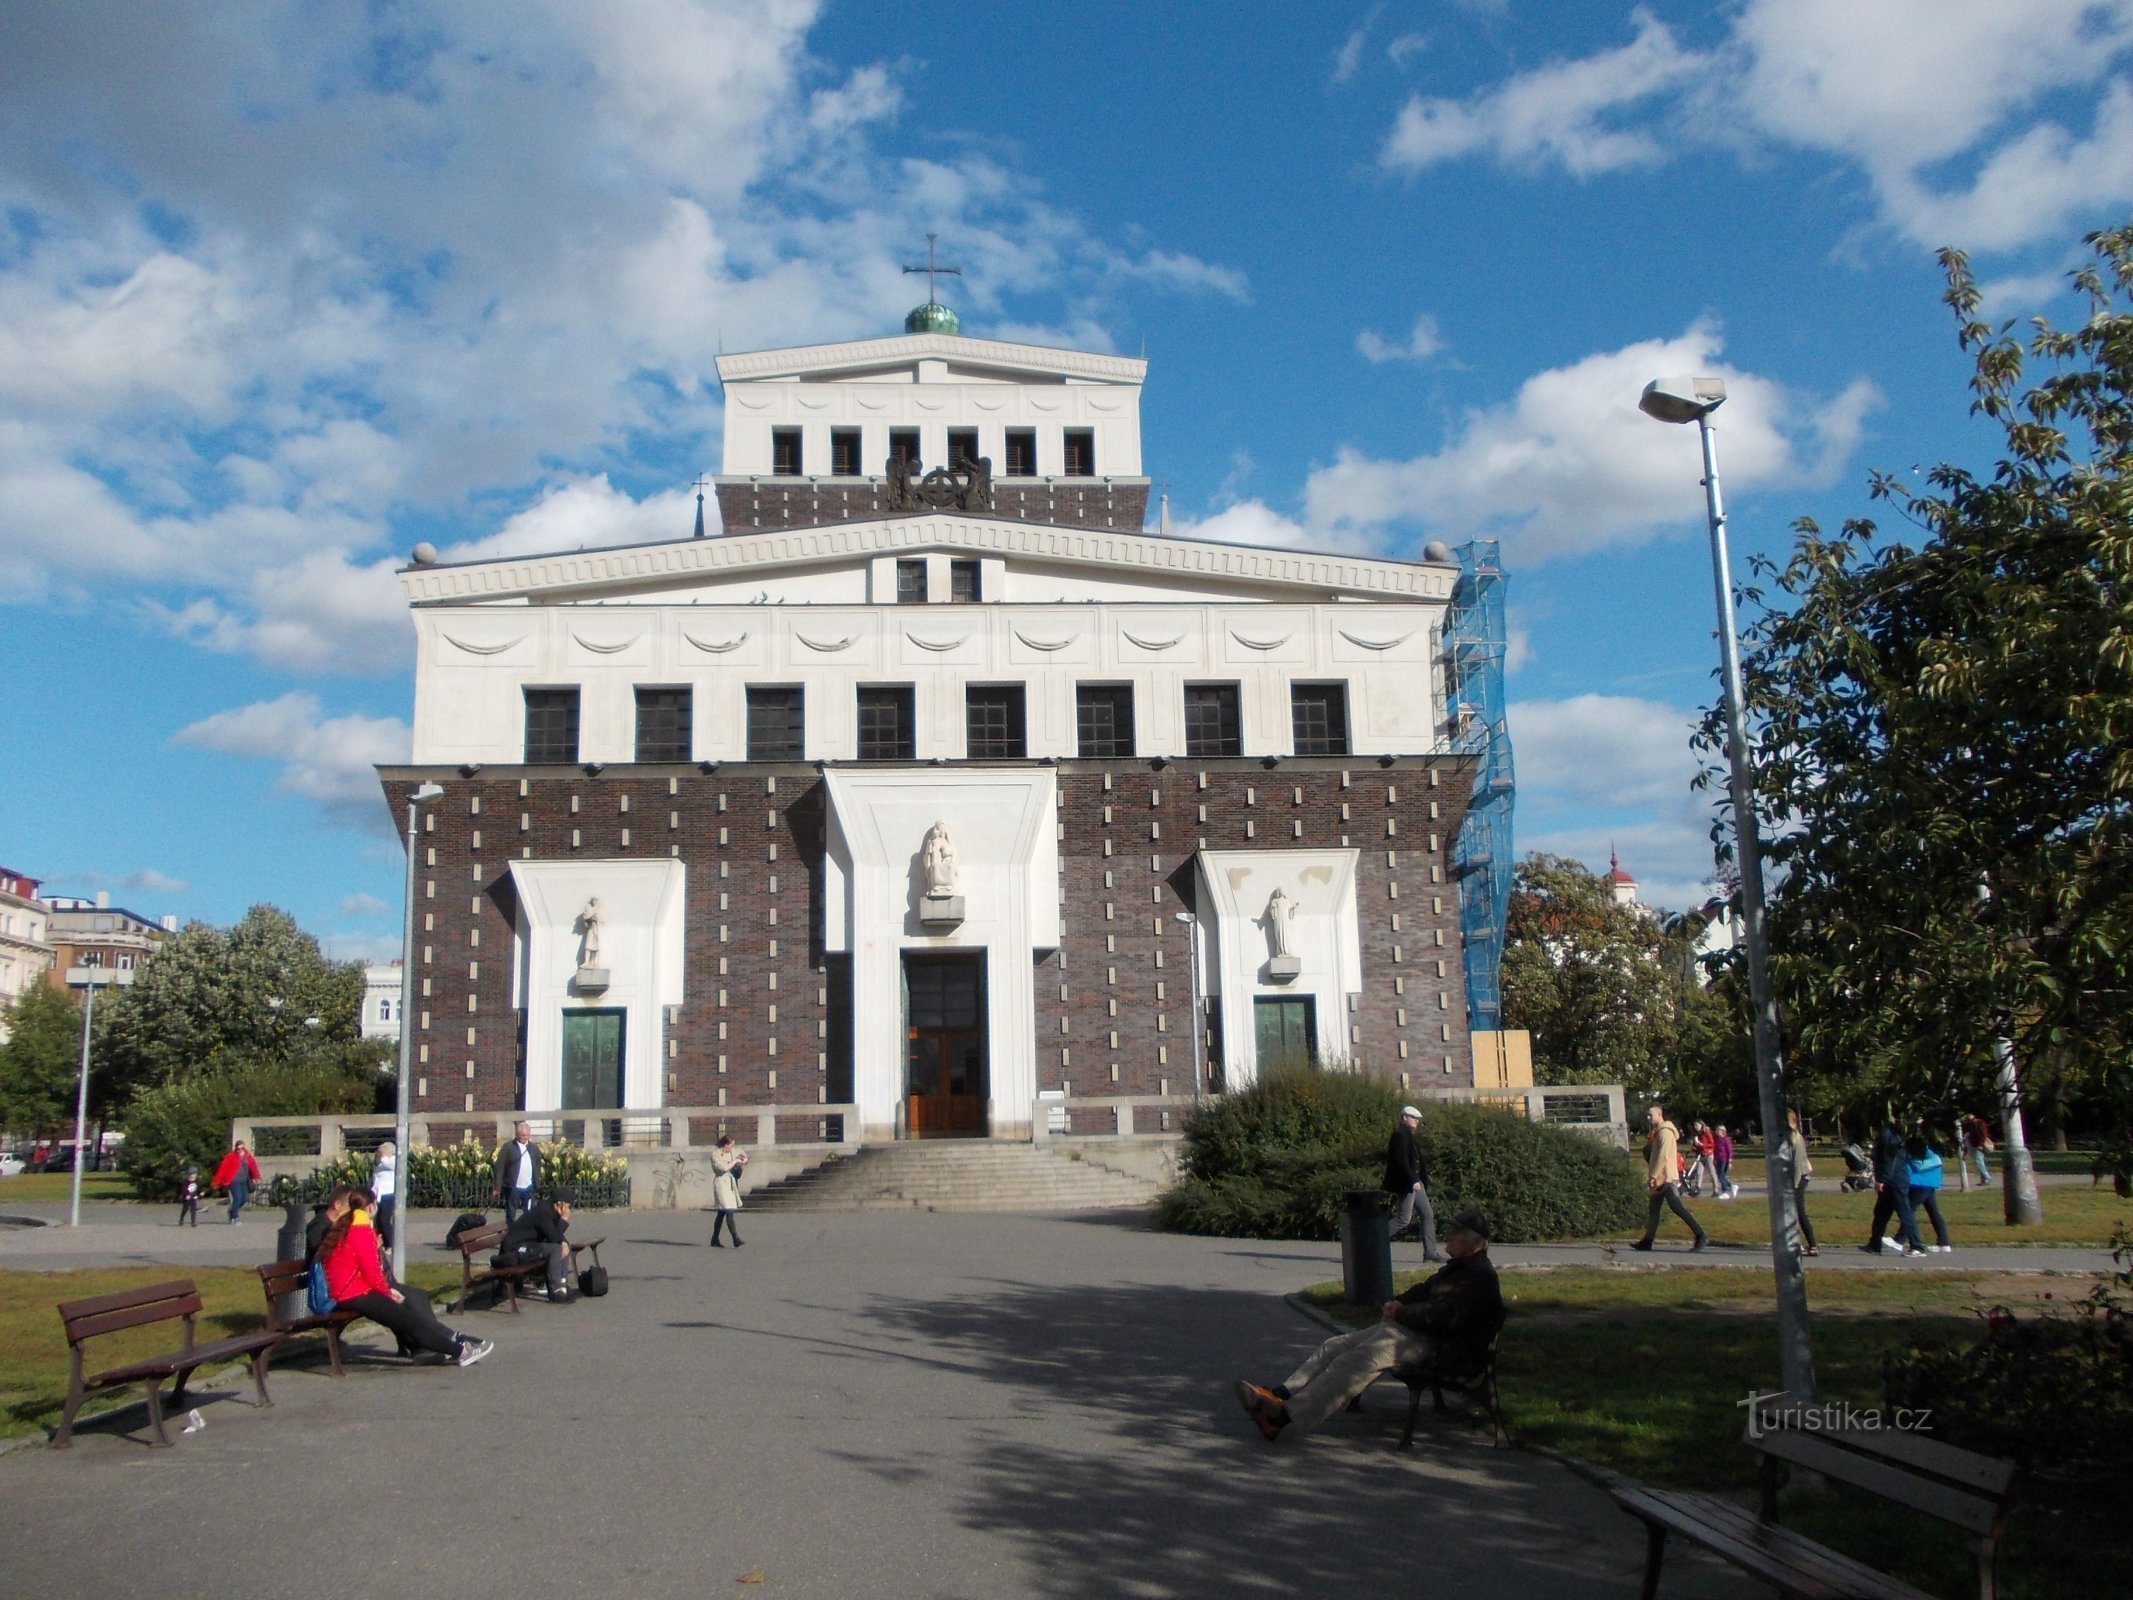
0, 1207, 1766, 1600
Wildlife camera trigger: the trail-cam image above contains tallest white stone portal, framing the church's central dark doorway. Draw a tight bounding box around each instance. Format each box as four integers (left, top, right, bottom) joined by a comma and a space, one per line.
823, 766, 1060, 1141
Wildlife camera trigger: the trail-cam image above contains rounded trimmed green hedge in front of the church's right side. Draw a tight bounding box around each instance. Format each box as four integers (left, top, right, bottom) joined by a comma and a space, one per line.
1152, 1069, 1645, 1244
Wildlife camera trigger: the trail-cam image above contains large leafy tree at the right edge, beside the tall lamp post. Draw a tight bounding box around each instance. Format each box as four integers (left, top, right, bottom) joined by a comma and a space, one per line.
1702, 228, 2133, 1169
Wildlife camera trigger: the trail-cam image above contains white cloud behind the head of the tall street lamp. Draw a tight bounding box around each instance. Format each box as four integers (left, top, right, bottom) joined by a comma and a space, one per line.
1303, 322, 1879, 565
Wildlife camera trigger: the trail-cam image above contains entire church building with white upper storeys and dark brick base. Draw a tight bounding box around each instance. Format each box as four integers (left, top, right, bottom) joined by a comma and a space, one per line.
380, 301, 1493, 1143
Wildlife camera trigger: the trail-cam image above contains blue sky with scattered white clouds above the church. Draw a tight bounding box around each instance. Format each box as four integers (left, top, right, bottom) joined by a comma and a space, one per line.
0, 0, 2133, 956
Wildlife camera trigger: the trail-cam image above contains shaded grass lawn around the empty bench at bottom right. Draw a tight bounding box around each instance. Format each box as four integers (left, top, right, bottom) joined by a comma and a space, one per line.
1305, 1280, 2124, 1600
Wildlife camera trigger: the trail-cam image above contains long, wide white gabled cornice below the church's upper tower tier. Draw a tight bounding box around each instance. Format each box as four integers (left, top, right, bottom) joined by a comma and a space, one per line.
399, 514, 1459, 606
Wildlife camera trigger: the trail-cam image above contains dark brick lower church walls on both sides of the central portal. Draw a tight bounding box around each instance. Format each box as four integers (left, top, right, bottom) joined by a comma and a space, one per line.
386, 757, 1474, 1139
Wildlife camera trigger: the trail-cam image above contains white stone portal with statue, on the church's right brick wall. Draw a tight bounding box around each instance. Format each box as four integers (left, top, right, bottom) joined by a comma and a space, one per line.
1199, 849, 1363, 1088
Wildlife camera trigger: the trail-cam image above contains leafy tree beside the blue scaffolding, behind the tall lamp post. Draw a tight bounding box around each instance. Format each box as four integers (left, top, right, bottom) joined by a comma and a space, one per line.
1502, 853, 1753, 1116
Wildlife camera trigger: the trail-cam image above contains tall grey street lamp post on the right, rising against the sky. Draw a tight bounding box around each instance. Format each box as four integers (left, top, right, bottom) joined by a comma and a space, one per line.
1638, 378, 1815, 1399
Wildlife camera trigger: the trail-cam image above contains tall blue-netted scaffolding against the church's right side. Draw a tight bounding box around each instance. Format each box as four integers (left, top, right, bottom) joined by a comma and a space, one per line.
1444, 540, 1517, 1030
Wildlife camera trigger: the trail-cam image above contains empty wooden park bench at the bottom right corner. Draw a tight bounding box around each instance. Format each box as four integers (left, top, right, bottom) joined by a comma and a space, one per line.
1615, 1395, 2014, 1600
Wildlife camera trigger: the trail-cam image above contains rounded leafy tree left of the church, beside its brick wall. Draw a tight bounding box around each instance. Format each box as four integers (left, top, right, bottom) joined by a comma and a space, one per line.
105, 905, 363, 1090
